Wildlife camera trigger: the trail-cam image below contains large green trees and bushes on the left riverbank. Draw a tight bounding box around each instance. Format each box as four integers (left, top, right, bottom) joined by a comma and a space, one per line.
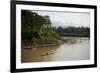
21, 10, 59, 44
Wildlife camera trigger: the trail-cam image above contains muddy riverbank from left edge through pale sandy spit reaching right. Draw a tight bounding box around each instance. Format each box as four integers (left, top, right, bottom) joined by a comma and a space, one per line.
22, 37, 89, 50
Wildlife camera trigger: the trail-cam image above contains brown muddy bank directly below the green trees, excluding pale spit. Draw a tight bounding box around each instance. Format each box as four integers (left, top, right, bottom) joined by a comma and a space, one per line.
22, 40, 64, 50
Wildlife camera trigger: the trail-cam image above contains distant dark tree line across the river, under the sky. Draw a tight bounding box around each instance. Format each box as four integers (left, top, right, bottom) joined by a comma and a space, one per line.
54, 26, 90, 37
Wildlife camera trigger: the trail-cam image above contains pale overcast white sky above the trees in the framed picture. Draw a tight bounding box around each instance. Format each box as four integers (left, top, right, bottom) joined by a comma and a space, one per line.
33, 10, 90, 27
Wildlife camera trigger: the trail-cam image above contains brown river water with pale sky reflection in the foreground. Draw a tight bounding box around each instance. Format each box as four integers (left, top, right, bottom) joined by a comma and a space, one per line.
21, 38, 90, 63
